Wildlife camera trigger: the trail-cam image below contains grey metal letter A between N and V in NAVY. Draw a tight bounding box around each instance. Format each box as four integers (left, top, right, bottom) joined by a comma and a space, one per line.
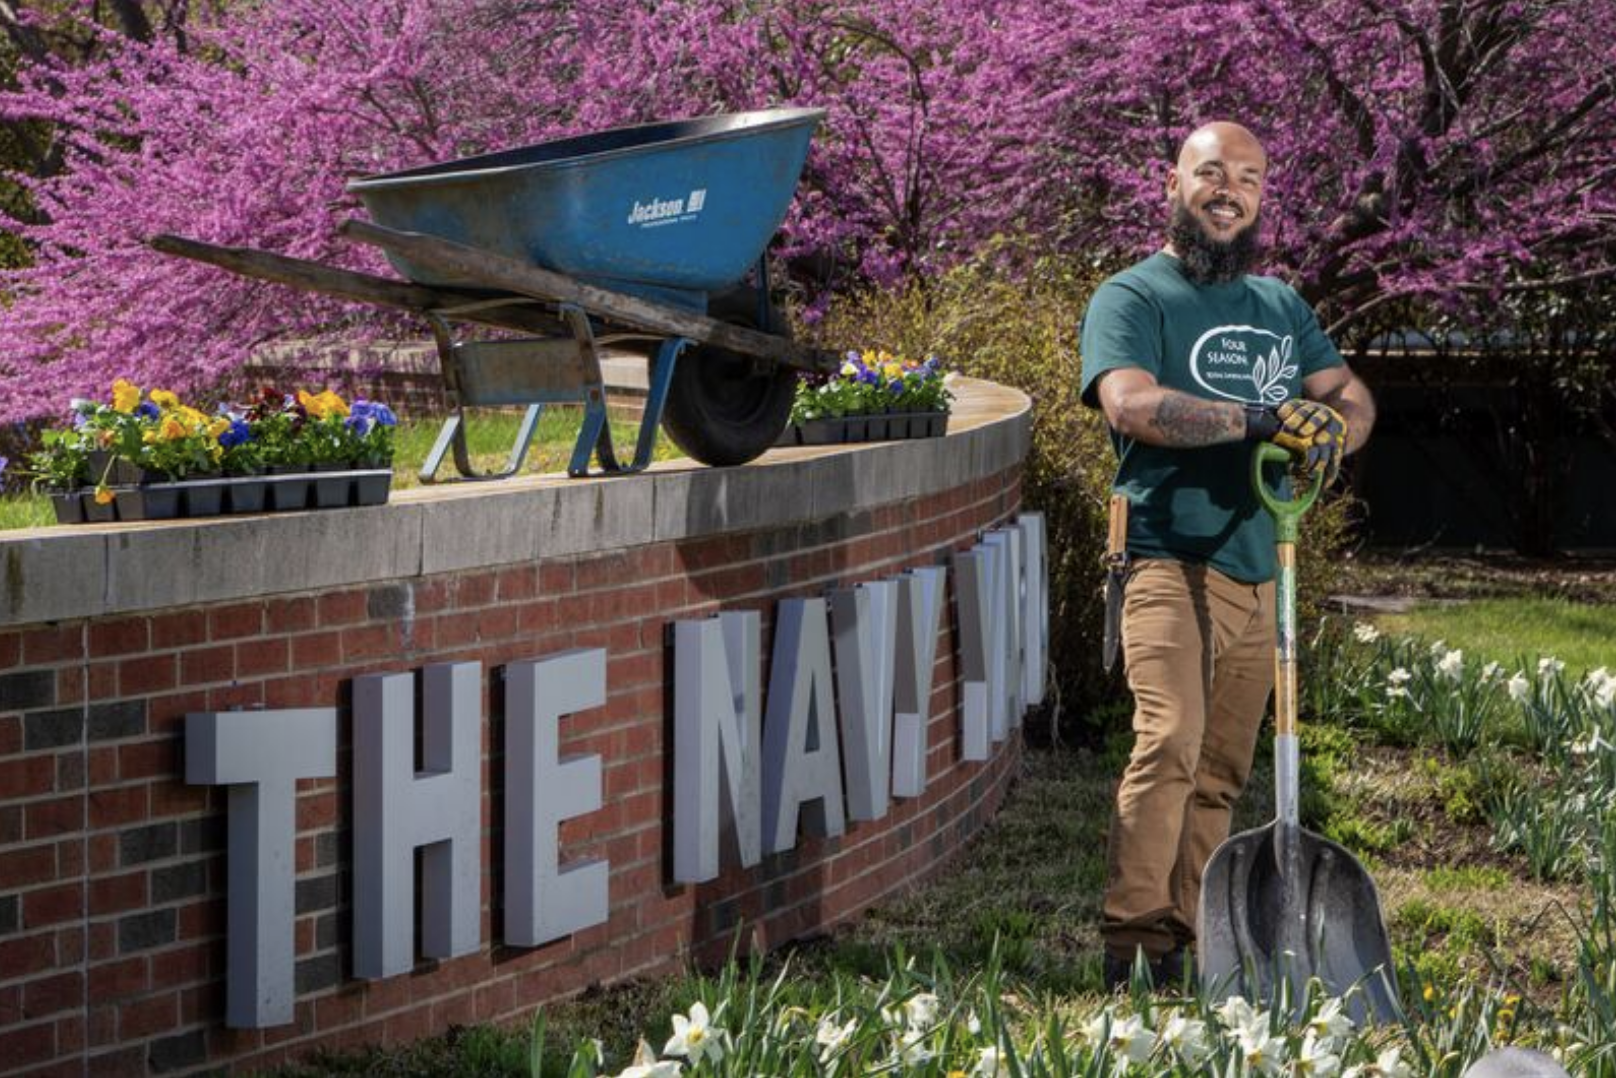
763, 600, 847, 853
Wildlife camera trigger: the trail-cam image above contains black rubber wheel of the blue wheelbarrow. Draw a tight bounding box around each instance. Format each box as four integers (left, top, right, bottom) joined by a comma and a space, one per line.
663, 288, 797, 467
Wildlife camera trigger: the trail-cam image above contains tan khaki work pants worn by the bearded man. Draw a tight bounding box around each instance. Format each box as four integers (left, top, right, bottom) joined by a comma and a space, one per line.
1100, 559, 1273, 960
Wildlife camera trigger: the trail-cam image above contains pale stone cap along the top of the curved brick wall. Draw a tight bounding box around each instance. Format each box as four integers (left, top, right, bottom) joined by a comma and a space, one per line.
0, 378, 1031, 627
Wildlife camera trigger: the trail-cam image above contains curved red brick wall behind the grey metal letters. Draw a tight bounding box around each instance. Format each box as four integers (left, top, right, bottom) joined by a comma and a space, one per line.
0, 465, 1020, 1075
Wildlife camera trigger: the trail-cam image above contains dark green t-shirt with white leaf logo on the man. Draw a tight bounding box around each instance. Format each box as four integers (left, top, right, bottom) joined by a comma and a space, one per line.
1081, 252, 1341, 583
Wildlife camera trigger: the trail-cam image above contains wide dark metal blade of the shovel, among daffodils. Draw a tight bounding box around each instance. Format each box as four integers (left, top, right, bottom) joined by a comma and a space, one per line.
1196, 821, 1401, 1021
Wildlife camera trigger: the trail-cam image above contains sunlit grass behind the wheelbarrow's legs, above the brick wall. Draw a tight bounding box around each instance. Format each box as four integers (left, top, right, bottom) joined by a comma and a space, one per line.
0, 406, 684, 530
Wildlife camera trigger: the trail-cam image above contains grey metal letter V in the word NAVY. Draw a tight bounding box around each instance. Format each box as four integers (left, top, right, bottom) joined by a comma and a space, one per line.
831, 580, 898, 819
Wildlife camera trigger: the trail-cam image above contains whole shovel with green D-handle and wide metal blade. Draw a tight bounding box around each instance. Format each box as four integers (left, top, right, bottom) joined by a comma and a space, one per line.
1196, 444, 1401, 1021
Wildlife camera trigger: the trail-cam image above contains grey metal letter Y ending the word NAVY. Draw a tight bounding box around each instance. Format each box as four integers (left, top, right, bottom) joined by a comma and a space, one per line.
892, 567, 949, 797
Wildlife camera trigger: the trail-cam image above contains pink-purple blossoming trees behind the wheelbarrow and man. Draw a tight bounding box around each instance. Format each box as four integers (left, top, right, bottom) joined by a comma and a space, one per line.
0, 0, 1616, 419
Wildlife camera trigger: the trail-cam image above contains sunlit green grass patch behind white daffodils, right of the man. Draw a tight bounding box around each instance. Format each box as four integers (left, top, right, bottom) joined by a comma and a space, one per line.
1375, 598, 1616, 677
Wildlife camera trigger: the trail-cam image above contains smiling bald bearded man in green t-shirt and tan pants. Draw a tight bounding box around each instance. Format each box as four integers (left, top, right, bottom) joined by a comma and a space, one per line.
1081, 123, 1375, 987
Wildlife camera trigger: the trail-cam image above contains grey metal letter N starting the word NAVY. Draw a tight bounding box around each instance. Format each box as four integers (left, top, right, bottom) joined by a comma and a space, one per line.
674, 611, 763, 884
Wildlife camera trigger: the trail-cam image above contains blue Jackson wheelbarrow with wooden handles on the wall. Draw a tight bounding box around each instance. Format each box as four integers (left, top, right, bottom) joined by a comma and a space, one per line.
150, 108, 839, 482
